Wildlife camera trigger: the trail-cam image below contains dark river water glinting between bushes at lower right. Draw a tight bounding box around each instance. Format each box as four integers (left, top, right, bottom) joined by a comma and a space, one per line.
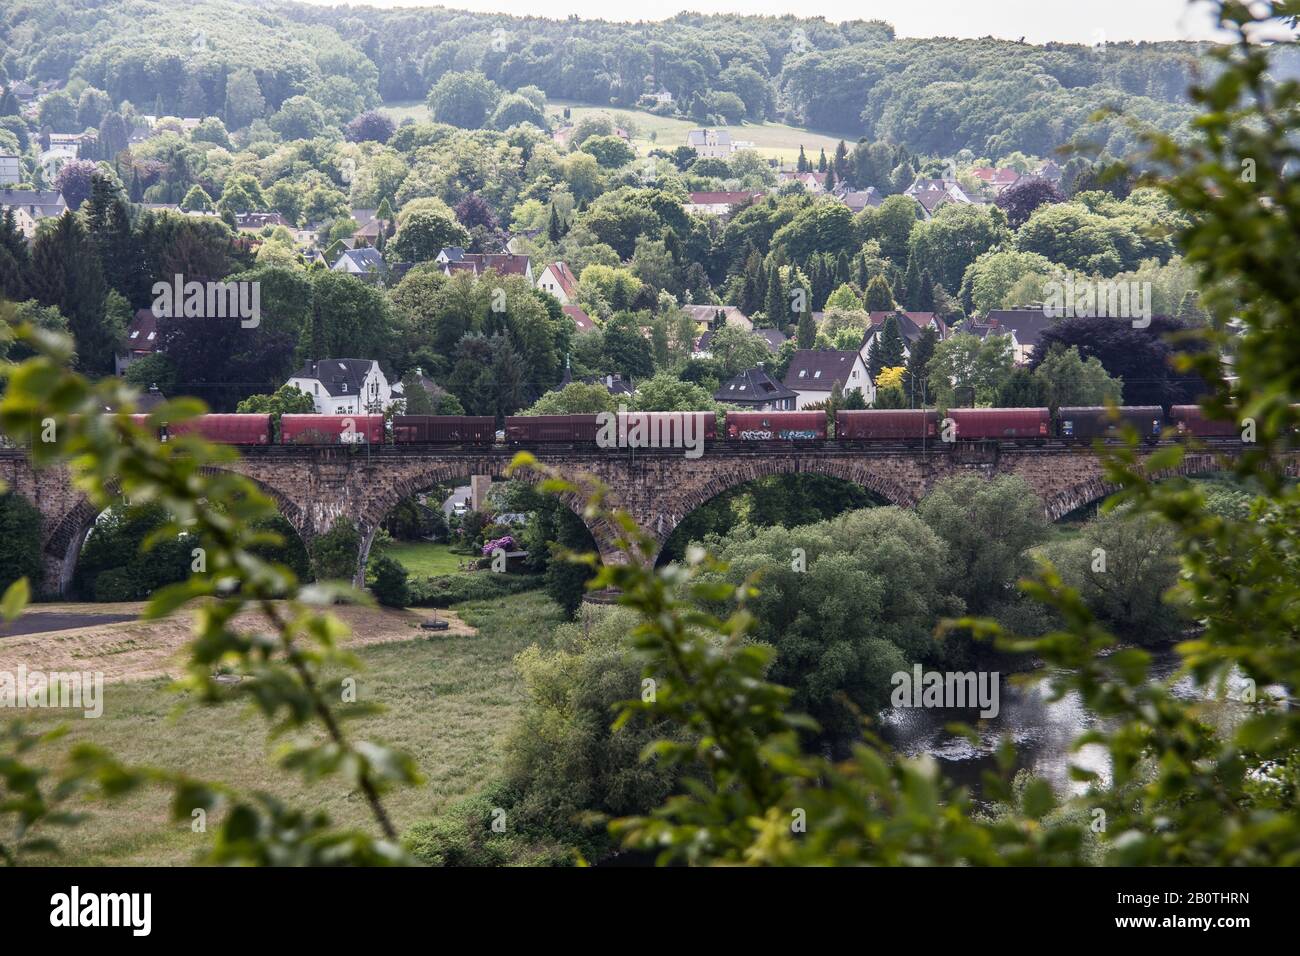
880, 648, 1263, 797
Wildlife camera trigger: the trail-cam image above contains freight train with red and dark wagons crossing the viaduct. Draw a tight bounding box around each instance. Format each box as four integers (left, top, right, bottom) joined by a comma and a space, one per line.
124, 405, 1240, 447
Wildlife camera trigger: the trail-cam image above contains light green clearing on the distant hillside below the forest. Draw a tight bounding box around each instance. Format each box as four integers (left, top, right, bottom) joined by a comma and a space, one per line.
380, 100, 840, 163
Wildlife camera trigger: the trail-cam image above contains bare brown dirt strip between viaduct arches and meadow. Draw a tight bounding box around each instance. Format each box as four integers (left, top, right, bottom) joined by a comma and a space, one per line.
0, 602, 475, 682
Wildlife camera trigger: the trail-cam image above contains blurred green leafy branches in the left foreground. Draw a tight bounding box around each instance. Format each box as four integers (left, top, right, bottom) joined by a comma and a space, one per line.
0, 310, 419, 865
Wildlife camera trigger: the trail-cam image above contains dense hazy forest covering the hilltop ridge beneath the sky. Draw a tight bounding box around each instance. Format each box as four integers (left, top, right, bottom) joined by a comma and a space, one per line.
0, 0, 1263, 159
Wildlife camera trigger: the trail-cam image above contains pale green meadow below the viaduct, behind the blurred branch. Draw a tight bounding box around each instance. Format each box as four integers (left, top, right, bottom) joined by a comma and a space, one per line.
13, 592, 559, 865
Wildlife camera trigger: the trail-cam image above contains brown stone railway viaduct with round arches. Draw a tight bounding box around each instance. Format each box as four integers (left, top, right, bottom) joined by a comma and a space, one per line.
0, 441, 1279, 594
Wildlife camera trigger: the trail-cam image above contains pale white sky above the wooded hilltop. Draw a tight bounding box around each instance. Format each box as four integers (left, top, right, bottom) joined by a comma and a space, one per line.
307, 0, 1214, 44
